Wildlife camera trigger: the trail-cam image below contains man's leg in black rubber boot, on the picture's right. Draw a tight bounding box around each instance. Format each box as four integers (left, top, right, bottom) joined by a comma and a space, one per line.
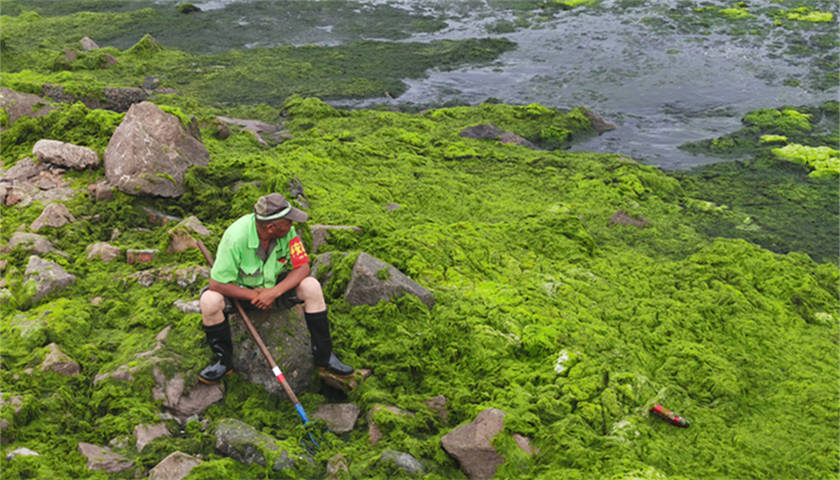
295, 277, 353, 375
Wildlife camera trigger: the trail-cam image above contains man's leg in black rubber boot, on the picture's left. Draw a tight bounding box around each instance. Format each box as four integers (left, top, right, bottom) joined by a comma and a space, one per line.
198, 290, 233, 383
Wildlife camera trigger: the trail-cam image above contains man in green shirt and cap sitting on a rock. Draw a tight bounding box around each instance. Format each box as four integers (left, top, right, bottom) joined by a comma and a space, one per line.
199, 193, 353, 383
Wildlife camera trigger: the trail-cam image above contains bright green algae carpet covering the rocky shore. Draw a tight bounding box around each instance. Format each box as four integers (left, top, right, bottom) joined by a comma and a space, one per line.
0, 2, 840, 480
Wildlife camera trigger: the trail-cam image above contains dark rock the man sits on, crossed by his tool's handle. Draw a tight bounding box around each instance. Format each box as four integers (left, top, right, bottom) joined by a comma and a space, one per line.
231, 306, 314, 398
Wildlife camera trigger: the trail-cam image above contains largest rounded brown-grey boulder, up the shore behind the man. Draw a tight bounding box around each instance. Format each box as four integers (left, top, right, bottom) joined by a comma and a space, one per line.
104, 102, 210, 197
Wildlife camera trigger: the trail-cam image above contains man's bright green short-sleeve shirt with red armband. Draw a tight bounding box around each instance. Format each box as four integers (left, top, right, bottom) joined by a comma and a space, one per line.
210, 213, 309, 288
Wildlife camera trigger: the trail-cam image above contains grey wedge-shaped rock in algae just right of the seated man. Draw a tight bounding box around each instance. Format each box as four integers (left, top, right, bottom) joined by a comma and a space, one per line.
344, 252, 435, 308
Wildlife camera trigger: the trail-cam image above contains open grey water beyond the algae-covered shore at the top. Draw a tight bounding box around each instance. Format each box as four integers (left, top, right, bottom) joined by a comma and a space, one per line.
93, 0, 840, 170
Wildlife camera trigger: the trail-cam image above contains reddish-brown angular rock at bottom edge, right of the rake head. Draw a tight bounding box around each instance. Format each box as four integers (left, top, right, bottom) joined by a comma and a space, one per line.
441, 408, 505, 480
